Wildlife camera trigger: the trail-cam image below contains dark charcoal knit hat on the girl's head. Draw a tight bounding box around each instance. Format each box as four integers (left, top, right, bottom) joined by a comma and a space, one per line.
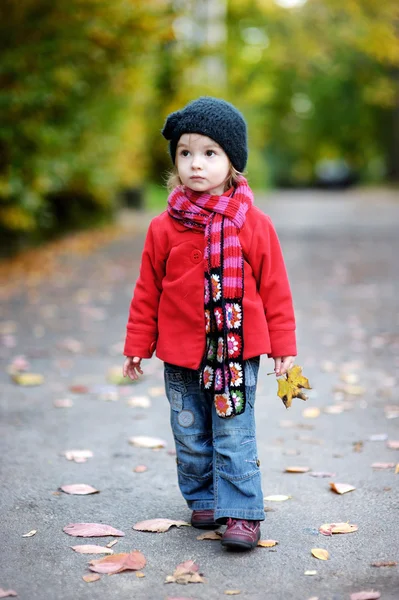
162, 96, 248, 172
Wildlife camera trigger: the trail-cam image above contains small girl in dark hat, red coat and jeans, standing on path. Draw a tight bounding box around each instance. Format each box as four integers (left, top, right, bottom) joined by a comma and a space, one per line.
123, 97, 296, 549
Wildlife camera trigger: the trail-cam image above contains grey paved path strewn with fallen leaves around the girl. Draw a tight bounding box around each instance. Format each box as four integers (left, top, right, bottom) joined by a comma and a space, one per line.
0, 190, 399, 600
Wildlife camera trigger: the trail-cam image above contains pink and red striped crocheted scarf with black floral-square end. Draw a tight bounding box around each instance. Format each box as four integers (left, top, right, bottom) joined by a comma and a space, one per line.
168, 177, 253, 417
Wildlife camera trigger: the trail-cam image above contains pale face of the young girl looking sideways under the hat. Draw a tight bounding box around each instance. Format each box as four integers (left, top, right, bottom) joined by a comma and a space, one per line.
176, 133, 230, 196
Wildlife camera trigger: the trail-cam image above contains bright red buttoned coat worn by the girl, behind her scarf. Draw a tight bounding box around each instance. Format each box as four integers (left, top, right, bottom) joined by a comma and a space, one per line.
124, 206, 296, 369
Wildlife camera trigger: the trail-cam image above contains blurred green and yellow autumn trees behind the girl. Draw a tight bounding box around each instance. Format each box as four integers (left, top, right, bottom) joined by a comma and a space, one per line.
0, 0, 399, 253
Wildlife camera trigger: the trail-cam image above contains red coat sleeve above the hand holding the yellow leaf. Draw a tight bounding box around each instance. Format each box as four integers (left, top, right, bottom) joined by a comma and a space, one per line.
249, 214, 297, 357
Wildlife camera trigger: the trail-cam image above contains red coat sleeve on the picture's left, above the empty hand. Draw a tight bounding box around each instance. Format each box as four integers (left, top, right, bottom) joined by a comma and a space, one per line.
123, 218, 167, 358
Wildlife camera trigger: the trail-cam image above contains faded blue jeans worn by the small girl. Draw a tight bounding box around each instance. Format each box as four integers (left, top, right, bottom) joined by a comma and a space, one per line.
165, 357, 265, 523
